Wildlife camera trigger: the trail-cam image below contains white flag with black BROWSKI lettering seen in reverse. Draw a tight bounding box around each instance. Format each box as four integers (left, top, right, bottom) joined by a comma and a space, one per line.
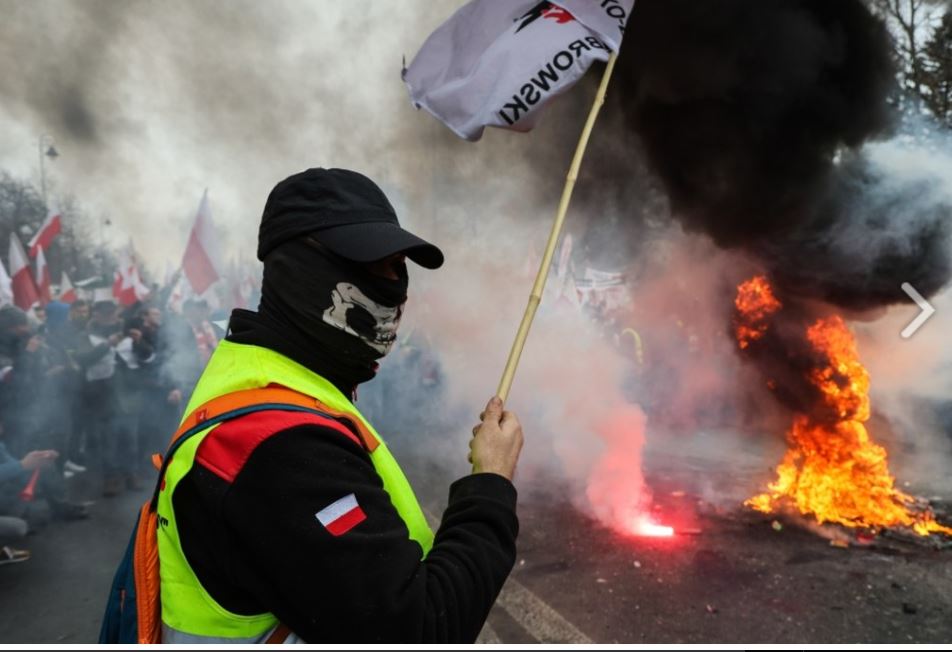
403, 0, 635, 140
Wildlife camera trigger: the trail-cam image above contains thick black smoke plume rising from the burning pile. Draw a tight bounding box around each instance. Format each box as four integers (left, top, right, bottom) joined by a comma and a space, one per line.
613, 0, 952, 414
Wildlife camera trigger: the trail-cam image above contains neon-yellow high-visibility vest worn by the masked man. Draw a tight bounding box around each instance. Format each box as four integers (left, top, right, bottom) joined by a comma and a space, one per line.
158, 341, 433, 643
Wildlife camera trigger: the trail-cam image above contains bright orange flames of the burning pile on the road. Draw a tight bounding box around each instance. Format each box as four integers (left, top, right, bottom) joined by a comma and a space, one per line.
735, 276, 952, 536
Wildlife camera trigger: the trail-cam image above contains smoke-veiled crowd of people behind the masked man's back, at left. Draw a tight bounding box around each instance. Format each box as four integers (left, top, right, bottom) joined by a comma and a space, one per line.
0, 297, 222, 565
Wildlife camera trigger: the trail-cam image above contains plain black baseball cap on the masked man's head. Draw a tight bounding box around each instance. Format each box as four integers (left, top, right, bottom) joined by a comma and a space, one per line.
258, 168, 443, 269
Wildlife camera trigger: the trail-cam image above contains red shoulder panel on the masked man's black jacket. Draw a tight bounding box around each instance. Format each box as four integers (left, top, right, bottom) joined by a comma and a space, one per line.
195, 410, 363, 482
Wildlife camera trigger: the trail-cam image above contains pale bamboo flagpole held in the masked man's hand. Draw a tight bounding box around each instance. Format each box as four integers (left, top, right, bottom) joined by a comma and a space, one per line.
496, 52, 618, 401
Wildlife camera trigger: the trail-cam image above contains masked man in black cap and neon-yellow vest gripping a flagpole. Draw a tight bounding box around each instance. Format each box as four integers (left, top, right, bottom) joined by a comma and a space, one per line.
158, 169, 522, 644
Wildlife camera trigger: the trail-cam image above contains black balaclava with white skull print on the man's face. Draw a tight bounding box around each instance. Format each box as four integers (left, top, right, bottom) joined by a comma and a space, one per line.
259, 238, 408, 385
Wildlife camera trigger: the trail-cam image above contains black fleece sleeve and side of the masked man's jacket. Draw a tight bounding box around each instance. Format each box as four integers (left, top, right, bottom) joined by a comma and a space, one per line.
167, 320, 518, 643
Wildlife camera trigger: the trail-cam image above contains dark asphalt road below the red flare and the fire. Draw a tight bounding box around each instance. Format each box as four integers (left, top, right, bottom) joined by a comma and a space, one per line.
498, 484, 952, 643
